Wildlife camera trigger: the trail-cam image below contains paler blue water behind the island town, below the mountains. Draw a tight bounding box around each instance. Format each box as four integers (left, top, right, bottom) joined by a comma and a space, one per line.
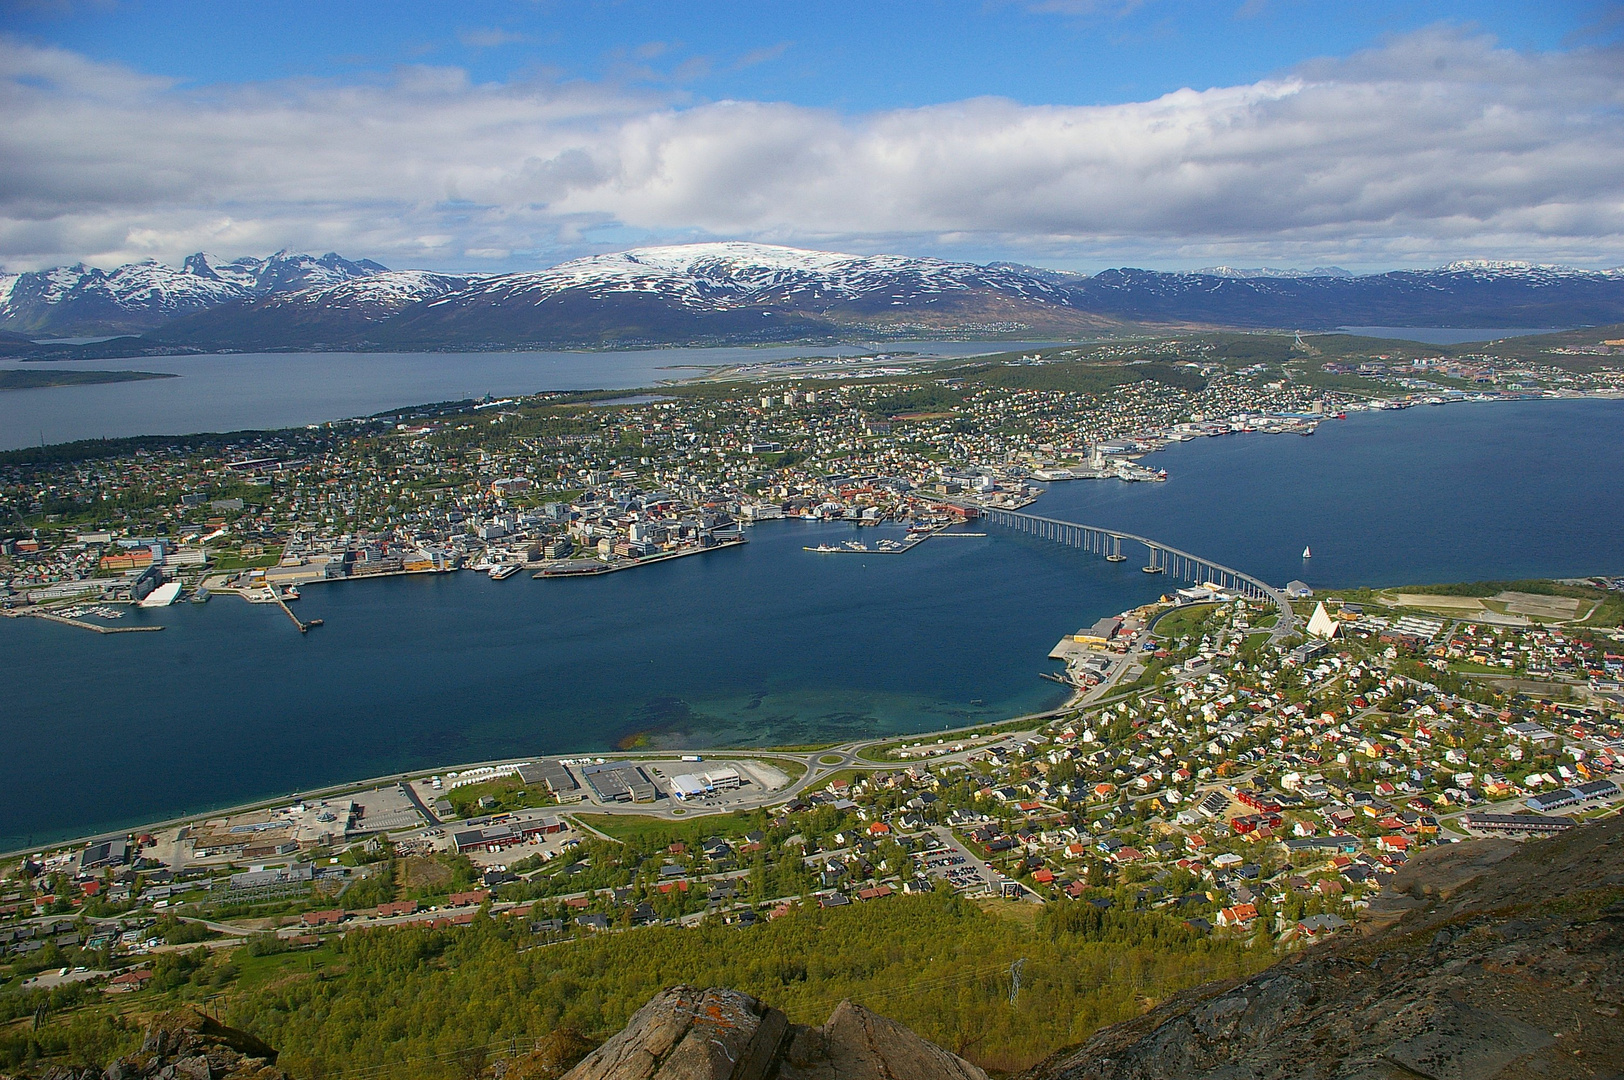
0, 341, 1041, 450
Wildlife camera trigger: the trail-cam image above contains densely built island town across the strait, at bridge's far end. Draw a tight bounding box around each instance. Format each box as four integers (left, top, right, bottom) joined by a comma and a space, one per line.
9, 336, 1621, 613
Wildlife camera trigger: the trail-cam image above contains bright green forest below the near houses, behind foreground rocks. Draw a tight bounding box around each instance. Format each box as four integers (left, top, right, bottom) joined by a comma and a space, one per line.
0, 895, 1273, 1080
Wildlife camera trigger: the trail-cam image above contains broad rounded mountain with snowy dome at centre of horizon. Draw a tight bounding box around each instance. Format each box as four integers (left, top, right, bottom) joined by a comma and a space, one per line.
161, 244, 1109, 348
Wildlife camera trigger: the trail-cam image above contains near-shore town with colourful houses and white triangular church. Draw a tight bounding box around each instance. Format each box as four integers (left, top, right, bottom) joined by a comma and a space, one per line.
0, 578, 1624, 992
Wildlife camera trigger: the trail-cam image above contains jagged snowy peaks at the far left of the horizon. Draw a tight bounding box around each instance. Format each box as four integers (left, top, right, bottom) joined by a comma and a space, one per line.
0, 252, 385, 336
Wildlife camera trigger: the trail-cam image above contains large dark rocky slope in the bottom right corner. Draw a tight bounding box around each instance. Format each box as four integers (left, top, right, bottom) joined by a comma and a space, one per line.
1025, 819, 1624, 1080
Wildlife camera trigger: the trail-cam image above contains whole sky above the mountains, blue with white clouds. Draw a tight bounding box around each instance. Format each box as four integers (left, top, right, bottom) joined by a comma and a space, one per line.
0, 0, 1624, 270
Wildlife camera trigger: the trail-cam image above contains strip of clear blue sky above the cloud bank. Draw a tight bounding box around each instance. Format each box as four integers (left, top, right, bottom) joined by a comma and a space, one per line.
11, 0, 1609, 112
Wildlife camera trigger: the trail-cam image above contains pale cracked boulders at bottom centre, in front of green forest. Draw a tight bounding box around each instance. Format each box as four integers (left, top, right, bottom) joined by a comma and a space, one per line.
565, 986, 986, 1080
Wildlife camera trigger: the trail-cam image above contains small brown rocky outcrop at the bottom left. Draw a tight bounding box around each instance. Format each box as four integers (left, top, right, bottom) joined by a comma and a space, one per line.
14, 1009, 287, 1080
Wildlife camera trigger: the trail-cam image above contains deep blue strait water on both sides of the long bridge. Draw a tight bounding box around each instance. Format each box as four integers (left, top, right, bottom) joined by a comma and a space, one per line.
0, 401, 1624, 848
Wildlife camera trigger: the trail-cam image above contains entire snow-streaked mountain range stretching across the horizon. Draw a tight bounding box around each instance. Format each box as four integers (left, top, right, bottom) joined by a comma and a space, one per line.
0, 242, 1624, 351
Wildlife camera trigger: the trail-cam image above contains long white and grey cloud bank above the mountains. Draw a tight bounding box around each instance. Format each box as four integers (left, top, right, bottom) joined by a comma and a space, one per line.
0, 28, 1624, 270
